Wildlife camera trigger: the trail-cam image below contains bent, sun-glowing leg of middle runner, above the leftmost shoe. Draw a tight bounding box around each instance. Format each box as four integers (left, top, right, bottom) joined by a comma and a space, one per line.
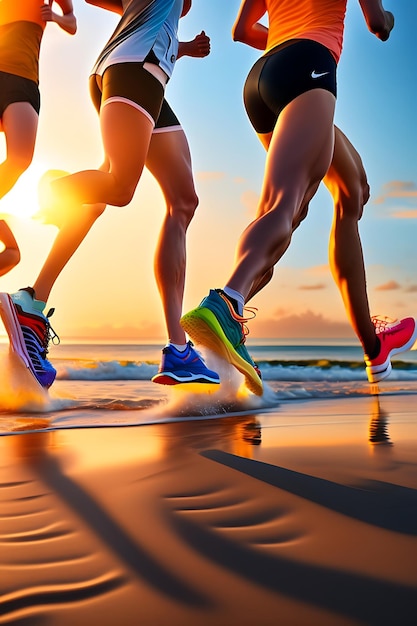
33, 102, 153, 302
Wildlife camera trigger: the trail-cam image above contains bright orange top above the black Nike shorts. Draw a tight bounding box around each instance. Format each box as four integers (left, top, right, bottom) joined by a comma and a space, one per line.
265, 0, 347, 62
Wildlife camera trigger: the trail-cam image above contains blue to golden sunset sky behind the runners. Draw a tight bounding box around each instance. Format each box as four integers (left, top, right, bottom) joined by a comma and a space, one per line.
0, 0, 417, 341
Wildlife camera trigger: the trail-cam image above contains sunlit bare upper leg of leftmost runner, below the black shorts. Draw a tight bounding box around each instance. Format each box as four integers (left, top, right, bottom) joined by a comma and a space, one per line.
0, 102, 38, 198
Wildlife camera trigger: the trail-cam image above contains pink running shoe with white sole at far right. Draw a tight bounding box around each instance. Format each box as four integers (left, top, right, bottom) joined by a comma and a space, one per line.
365, 317, 417, 383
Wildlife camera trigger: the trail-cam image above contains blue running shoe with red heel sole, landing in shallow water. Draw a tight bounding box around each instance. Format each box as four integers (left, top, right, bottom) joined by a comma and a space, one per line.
152, 341, 220, 385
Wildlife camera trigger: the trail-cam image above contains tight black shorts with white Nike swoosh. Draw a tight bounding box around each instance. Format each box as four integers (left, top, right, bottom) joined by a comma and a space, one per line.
243, 39, 337, 134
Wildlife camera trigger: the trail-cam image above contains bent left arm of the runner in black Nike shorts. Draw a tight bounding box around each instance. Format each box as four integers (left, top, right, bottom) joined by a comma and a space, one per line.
232, 0, 268, 50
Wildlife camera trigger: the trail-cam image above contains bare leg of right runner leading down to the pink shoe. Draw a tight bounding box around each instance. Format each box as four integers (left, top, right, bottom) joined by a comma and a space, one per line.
324, 128, 376, 354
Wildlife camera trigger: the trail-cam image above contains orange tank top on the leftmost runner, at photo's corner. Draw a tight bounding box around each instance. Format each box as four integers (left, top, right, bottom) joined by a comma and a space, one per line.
0, 0, 45, 83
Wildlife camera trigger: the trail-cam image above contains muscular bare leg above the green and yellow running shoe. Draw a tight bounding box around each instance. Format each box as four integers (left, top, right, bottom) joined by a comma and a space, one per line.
227, 89, 335, 299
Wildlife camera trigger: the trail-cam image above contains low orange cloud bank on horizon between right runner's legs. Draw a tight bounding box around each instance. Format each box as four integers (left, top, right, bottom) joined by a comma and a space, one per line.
250, 311, 355, 339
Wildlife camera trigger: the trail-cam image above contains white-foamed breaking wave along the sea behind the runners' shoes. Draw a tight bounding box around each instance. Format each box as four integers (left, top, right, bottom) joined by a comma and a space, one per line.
55, 359, 417, 382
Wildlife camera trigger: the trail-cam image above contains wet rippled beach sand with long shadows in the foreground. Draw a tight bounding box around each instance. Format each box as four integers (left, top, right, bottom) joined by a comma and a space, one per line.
0, 394, 417, 626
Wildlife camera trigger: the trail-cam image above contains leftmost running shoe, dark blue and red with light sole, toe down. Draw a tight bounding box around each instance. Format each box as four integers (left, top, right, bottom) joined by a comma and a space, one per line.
0, 287, 59, 389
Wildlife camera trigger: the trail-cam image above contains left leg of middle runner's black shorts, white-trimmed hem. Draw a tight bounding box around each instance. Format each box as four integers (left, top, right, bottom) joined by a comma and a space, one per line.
90, 62, 164, 124
